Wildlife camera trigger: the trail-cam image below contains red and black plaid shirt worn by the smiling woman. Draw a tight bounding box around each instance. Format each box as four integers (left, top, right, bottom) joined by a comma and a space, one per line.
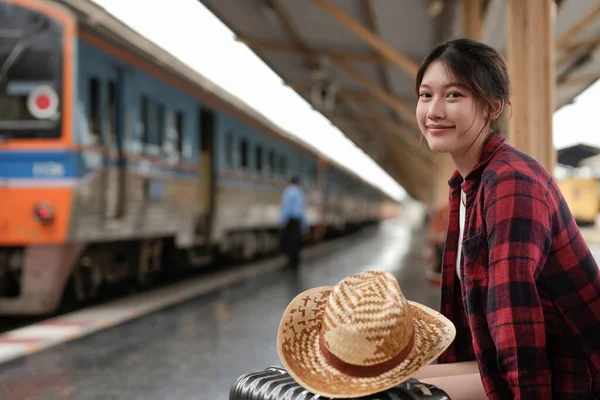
438, 135, 600, 400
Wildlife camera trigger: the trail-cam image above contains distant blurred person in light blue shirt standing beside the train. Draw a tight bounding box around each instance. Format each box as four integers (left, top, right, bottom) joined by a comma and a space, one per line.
280, 176, 308, 270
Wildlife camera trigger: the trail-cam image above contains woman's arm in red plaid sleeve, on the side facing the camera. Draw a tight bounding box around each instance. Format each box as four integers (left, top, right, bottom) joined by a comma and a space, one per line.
482, 171, 552, 399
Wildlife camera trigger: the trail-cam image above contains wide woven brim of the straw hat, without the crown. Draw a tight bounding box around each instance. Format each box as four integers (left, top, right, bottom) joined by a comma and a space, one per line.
277, 286, 456, 398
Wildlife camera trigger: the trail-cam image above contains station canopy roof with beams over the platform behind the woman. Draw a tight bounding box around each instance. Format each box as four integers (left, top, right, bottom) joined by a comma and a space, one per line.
199, 0, 600, 200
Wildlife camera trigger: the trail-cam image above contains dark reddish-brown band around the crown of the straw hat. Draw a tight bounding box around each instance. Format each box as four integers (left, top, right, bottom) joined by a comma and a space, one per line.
319, 331, 415, 378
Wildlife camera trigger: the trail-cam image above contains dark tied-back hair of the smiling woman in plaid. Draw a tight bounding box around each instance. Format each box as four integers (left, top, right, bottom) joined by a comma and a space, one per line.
415, 39, 510, 135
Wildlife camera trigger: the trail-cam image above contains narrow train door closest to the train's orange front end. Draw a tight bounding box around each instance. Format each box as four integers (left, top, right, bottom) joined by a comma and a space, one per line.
104, 69, 126, 220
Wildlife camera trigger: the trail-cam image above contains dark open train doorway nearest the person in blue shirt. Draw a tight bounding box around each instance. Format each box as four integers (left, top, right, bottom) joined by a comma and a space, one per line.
198, 107, 215, 240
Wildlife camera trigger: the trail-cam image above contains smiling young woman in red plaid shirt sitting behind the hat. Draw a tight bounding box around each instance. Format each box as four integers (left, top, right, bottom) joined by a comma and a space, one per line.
415, 39, 600, 400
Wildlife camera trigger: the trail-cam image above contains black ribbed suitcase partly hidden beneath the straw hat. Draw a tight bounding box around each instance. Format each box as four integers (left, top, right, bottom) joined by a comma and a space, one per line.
229, 367, 450, 400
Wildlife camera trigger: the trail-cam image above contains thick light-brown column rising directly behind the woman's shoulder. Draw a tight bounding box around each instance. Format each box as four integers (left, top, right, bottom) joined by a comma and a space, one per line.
507, 0, 556, 173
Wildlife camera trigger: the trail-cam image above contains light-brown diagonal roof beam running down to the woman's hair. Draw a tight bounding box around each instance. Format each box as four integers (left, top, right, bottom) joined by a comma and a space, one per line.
313, 0, 419, 79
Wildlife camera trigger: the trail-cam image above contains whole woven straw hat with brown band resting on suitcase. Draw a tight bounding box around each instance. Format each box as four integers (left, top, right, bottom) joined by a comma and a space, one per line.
277, 271, 456, 398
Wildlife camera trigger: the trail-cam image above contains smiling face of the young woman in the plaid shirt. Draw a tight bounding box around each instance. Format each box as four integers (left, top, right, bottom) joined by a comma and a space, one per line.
417, 60, 487, 155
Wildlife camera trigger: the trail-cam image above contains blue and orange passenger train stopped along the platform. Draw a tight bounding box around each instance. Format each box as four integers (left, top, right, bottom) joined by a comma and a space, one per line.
0, 0, 399, 316
